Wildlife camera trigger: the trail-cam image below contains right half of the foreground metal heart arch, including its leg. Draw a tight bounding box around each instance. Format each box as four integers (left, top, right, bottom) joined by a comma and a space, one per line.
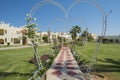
67, 0, 107, 79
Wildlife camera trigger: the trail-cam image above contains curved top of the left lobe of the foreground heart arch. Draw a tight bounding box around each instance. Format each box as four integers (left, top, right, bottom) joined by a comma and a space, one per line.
29, 0, 67, 17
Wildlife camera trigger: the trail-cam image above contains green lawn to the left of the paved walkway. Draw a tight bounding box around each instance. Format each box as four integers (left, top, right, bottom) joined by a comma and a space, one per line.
0, 46, 50, 80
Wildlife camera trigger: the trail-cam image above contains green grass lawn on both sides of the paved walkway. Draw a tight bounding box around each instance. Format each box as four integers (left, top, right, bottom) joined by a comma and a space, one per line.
0, 43, 120, 80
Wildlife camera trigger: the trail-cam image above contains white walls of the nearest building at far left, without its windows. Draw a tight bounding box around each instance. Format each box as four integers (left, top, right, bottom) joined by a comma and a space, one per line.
0, 22, 22, 45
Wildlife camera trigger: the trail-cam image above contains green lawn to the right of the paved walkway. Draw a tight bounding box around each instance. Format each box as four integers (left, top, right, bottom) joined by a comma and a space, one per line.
76, 43, 120, 80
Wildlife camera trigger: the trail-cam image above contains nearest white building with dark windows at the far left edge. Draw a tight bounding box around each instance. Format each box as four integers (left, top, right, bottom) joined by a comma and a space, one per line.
0, 22, 22, 45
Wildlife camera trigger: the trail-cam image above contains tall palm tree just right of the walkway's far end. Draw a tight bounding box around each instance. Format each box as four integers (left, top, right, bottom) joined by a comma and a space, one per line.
70, 25, 81, 41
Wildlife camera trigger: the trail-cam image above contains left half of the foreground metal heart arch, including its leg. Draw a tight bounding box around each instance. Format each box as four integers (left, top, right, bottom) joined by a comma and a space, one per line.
28, 0, 67, 77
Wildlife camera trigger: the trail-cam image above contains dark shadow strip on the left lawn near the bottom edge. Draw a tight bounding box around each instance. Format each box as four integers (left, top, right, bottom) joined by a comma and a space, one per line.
0, 72, 32, 77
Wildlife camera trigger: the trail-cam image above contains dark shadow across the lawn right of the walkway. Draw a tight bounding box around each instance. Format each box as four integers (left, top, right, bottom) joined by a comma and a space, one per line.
92, 58, 120, 72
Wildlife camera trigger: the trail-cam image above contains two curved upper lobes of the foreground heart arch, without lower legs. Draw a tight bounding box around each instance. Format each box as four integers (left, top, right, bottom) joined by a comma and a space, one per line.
29, 0, 106, 36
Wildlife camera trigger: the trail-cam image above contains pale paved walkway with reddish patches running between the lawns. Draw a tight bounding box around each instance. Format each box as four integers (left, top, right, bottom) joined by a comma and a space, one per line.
46, 47, 84, 80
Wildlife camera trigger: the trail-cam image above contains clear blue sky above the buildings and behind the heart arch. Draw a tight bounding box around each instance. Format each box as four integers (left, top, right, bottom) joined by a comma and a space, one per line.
0, 0, 120, 35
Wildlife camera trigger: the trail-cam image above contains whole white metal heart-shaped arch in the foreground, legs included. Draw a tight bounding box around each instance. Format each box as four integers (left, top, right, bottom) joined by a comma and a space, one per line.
27, 0, 107, 79
